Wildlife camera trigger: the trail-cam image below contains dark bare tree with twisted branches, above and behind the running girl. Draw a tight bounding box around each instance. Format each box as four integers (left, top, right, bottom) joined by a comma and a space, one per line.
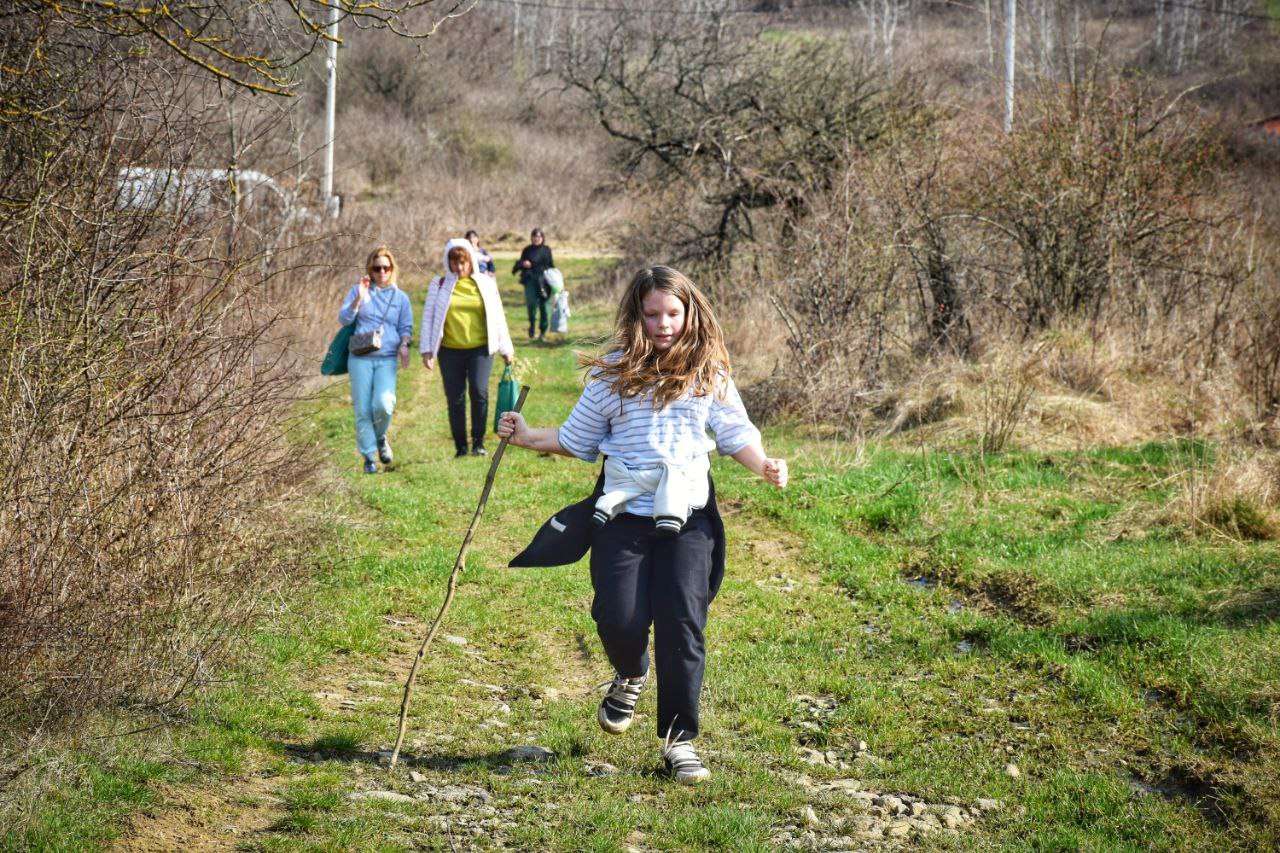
559, 15, 931, 263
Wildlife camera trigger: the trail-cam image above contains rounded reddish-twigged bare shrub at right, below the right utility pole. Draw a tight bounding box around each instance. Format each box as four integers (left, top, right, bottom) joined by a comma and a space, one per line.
973, 79, 1224, 333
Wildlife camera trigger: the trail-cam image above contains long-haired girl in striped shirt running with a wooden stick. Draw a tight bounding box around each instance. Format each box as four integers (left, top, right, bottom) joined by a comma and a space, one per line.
498, 266, 787, 783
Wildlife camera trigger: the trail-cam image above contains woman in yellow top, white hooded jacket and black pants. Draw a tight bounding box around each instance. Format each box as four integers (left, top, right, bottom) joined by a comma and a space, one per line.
419, 240, 515, 457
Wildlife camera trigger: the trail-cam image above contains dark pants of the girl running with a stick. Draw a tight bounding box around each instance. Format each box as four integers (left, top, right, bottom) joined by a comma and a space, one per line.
591, 511, 716, 739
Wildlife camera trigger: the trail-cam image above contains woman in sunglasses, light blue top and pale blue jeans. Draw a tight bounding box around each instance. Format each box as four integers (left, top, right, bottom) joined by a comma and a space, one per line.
338, 246, 413, 474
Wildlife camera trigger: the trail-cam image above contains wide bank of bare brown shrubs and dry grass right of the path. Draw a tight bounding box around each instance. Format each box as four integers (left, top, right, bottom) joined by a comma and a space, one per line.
751, 65, 1276, 451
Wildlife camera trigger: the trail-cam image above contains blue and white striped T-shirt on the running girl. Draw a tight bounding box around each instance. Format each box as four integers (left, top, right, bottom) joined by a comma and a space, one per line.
558, 363, 760, 515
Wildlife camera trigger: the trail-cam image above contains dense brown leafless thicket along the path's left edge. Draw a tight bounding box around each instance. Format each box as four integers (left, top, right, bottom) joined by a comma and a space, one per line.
0, 96, 300, 745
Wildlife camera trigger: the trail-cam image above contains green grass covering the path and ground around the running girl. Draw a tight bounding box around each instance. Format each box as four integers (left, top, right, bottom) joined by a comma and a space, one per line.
4, 261, 1280, 850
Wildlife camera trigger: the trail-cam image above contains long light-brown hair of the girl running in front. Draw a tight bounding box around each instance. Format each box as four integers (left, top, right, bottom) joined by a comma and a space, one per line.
582, 266, 730, 409
